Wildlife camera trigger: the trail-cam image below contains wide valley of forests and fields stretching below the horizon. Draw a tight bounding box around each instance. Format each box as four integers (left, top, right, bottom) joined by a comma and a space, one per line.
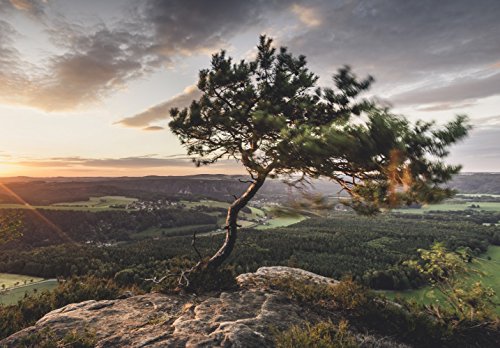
0, 176, 500, 342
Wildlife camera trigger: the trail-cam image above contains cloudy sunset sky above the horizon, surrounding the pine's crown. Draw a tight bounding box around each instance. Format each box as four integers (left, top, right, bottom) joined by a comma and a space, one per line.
0, 0, 500, 176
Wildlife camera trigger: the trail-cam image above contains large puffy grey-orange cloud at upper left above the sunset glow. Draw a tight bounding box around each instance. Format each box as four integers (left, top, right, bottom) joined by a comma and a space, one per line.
0, 17, 160, 112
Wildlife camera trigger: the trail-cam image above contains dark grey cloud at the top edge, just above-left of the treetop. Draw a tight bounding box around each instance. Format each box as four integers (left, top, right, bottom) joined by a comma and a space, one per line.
138, 0, 290, 58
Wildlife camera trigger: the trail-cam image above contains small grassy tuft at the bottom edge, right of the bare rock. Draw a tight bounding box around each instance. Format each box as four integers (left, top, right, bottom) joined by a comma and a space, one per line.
275, 320, 358, 348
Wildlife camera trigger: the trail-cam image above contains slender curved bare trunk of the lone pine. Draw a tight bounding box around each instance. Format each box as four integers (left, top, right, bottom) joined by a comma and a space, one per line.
203, 176, 266, 269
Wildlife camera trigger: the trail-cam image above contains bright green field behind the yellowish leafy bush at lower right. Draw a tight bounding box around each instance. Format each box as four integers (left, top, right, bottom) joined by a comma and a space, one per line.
383, 246, 500, 314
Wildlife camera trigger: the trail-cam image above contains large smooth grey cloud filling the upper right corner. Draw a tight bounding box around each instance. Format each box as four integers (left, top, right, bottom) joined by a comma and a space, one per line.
289, 0, 500, 92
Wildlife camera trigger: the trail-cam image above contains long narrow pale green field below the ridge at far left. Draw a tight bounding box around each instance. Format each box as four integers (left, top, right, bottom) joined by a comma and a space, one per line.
0, 196, 137, 212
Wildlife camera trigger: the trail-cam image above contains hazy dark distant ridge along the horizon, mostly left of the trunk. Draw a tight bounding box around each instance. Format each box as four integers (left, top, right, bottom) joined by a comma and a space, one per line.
0, 175, 340, 205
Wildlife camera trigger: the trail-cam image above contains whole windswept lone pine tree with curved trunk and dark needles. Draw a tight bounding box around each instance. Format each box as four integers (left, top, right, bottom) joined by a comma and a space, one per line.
169, 36, 469, 268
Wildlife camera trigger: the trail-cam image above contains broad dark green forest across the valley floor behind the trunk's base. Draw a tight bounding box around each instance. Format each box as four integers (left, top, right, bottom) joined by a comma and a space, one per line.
0, 213, 495, 290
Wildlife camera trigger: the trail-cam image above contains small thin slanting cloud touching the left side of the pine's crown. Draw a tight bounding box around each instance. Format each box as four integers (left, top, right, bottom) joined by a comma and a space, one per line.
116, 85, 201, 130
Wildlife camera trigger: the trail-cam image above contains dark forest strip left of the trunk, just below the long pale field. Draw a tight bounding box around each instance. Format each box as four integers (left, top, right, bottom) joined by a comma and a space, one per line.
0, 208, 217, 249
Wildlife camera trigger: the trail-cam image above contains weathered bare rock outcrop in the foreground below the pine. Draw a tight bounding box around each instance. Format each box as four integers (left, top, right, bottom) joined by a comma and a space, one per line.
0, 267, 408, 347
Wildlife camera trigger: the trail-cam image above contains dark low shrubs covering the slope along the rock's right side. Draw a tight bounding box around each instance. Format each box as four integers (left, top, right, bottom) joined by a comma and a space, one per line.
268, 278, 500, 347
